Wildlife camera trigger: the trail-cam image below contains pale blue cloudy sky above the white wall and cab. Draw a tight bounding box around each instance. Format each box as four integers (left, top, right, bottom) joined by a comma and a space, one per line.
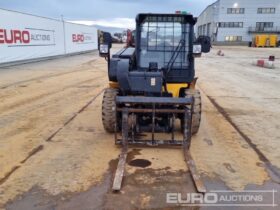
0, 0, 215, 27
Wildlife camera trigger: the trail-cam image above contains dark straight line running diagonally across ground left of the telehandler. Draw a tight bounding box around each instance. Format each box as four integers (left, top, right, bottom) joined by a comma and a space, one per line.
0, 89, 104, 186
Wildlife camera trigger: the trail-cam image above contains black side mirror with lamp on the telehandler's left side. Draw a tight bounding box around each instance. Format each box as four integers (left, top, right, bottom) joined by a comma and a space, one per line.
98, 31, 112, 58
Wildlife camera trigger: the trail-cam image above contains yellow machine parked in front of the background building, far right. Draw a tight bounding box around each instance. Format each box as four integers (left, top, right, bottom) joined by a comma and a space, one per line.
252, 34, 278, 47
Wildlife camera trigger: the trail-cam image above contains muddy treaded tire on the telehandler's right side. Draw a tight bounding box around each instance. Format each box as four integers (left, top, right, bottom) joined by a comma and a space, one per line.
181, 89, 201, 135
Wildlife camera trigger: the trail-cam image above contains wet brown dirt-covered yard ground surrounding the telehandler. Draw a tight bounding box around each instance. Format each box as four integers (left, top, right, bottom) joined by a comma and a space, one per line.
0, 46, 280, 210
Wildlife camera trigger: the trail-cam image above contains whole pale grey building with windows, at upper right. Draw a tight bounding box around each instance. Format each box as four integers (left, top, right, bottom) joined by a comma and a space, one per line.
196, 0, 280, 44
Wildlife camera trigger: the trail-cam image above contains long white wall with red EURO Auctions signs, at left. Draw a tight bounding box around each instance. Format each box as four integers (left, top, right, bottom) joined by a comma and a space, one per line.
0, 9, 97, 64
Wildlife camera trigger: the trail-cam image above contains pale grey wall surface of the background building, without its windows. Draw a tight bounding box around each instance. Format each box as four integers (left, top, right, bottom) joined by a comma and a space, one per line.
197, 0, 280, 42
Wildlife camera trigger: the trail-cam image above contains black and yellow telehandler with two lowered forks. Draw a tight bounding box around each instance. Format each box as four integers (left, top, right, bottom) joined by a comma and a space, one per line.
99, 14, 211, 192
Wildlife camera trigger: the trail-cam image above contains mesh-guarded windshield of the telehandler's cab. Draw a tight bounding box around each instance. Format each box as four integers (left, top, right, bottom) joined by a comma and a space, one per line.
140, 16, 190, 69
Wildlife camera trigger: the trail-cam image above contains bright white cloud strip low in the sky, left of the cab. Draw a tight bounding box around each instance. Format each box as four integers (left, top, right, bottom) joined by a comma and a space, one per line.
69, 18, 135, 29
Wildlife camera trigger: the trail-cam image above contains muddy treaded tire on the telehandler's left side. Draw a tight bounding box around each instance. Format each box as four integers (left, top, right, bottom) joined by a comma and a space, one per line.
102, 88, 119, 133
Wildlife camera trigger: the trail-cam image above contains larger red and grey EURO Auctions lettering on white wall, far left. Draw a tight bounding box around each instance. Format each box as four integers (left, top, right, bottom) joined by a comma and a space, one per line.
0, 28, 55, 47
